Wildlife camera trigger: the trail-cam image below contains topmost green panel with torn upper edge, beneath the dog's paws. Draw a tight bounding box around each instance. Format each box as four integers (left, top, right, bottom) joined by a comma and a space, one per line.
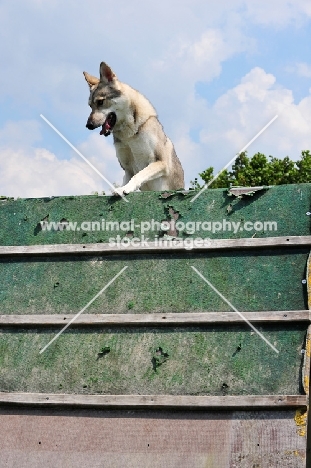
0, 184, 311, 245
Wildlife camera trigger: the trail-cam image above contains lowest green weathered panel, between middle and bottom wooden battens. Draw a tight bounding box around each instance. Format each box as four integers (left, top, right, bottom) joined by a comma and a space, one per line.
0, 324, 305, 395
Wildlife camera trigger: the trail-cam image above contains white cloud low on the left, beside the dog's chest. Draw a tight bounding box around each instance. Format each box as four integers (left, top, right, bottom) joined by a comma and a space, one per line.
0, 121, 122, 198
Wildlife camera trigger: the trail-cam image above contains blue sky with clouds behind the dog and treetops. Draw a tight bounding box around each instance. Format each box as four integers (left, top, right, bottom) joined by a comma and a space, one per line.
0, 0, 311, 197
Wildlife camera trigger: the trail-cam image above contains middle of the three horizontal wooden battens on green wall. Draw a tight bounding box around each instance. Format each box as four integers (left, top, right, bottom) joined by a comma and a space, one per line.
0, 310, 311, 326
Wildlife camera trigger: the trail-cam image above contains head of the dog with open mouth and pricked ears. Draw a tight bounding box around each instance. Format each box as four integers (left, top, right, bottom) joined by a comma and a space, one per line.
83, 62, 121, 136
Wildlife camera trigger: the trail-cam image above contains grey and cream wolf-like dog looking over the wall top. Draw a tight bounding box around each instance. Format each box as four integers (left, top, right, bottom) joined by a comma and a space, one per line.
83, 62, 184, 196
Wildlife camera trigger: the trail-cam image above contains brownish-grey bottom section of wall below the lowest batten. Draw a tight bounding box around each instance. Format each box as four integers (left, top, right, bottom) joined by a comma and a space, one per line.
0, 407, 305, 468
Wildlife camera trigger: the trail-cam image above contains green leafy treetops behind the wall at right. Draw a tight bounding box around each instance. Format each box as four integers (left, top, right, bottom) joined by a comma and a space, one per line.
191, 150, 311, 189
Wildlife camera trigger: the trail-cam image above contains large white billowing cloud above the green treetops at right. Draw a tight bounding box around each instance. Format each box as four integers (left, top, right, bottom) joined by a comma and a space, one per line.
200, 67, 311, 175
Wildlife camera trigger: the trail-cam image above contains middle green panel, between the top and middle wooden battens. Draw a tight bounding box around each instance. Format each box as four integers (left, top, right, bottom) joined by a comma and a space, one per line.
0, 249, 309, 314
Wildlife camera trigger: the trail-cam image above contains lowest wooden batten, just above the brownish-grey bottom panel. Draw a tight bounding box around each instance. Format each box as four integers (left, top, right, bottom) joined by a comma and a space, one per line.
0, 392, 307, 409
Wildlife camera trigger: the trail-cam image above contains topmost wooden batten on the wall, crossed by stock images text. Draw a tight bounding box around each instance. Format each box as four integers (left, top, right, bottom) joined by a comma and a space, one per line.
0, 236, 311, 257
